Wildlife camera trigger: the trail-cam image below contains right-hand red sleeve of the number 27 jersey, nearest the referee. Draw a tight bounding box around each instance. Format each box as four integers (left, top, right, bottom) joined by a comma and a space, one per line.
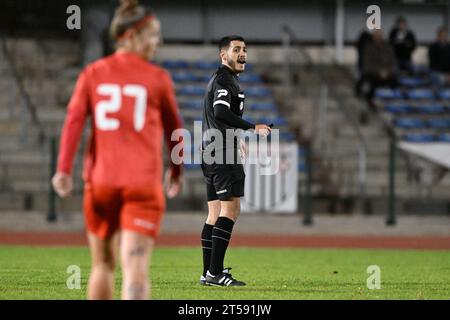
161, 73, 183, 177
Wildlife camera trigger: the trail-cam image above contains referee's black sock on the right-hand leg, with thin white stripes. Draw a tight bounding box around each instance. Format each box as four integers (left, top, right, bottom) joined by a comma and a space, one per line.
209, 217, 234, 275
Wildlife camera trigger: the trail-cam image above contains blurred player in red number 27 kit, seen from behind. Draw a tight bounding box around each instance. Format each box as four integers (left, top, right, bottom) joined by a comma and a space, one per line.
52, 0, 182, 299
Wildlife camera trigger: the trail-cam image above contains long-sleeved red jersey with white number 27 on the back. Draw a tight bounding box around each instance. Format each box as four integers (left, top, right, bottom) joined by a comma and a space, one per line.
58, 53, 182, 187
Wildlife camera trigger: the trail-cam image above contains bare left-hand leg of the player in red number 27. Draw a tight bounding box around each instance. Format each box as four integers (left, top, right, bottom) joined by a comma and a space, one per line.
87, 232, 118, 300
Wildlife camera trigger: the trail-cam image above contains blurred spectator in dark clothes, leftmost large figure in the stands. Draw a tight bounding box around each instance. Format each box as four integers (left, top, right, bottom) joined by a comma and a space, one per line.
362, 29, 397, 101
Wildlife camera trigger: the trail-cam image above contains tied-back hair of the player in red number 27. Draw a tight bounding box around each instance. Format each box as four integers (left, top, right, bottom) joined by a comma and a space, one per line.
109, 0, 154, 41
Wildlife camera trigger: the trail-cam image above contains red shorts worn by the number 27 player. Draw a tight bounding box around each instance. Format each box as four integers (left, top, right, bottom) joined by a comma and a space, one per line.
83, 183, 165, 239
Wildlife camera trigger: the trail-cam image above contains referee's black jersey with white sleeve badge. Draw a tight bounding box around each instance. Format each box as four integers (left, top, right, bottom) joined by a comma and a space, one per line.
202, 65, 245, 150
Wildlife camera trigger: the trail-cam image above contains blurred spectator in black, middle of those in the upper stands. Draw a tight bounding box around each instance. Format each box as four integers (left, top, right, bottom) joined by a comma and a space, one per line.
389, 17, 416, 71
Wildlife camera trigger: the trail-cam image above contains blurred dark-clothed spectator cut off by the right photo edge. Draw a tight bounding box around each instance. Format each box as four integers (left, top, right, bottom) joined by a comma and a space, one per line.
428, 27, 450, 84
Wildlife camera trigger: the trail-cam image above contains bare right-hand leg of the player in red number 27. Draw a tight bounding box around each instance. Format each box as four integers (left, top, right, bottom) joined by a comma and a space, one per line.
120, 230, 154, 300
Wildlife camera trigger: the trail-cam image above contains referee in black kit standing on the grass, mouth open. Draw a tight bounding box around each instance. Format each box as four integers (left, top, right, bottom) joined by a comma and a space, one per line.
200, 35, 271, 286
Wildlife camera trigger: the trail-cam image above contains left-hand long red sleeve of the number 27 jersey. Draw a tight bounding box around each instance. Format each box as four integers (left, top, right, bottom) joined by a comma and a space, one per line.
57, 69, 90, 174
